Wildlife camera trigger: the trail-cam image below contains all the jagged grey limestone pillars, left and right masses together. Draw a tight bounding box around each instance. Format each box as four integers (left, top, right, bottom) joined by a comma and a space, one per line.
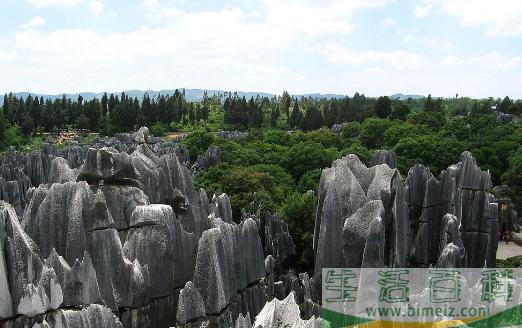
0, 127, 517, 328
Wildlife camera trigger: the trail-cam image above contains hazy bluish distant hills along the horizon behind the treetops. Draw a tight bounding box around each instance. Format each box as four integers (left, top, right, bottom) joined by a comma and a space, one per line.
0, 89, 424, 106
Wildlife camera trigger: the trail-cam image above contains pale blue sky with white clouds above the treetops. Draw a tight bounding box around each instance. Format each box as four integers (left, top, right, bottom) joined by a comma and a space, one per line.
0, 0, 522, 98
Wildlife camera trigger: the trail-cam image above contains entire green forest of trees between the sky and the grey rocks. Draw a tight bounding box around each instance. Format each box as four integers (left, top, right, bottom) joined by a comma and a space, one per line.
0, 92, 522, 269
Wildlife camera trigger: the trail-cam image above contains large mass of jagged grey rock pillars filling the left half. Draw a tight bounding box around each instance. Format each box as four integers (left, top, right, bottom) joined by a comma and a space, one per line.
0, 129, 276, 327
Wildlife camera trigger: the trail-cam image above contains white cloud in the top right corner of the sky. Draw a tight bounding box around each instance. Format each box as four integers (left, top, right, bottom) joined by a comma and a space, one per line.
416, 0, 522, 36
